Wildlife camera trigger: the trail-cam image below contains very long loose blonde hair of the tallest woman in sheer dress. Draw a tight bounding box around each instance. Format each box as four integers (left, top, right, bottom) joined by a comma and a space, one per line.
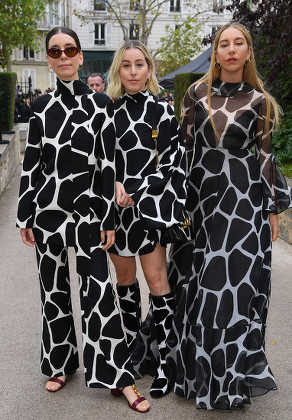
187, 22, 282, 136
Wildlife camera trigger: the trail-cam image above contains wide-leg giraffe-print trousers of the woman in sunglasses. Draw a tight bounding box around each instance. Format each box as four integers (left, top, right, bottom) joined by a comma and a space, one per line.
36, 244, 135, 388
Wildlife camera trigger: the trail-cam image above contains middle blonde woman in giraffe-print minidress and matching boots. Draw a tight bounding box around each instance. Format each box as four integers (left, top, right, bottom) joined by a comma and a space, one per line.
107, 41, 186, 397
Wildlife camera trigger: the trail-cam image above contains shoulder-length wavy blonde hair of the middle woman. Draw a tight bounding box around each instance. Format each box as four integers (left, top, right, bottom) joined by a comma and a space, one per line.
106, 40, 160, 98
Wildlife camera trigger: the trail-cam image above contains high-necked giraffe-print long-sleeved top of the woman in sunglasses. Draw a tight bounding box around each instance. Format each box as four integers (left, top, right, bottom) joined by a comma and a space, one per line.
17, 80, 115, 269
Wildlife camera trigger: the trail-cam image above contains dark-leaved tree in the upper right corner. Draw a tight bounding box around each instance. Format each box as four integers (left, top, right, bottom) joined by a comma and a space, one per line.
228, 0, 292, 111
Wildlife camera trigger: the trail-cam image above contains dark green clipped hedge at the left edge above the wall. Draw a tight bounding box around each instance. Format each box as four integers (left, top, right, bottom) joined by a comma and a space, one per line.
0, 72, 16, 131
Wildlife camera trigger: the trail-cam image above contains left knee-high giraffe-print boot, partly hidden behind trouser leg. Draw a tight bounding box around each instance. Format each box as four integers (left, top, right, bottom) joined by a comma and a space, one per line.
117, 280, 141, 354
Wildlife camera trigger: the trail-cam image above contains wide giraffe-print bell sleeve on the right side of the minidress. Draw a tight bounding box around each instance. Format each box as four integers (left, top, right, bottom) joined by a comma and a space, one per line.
125, 102, 186, 230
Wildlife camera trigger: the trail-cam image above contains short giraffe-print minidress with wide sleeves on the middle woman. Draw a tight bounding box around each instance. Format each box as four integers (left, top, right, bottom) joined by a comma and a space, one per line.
108, 91, 186, 256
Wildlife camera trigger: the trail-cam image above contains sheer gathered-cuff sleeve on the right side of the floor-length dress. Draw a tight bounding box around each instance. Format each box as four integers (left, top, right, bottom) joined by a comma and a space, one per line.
256, 99, 292, 214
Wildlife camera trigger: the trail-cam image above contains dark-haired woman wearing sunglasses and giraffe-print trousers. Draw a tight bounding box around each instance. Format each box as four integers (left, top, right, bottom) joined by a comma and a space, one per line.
17, 27, 149, 412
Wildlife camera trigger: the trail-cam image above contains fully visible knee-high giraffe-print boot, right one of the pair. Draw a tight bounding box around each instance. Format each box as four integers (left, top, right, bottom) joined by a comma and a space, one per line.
150, 293, 175, 398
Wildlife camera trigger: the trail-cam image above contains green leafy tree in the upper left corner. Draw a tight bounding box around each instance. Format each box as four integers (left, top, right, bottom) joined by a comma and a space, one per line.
0, 0, 49, 69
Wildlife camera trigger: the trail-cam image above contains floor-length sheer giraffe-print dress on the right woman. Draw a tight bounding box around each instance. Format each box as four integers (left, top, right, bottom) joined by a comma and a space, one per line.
168, 80, 291, 409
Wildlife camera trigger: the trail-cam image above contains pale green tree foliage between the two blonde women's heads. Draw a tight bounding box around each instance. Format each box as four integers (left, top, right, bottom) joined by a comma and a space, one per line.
155, 16, 202, 77
